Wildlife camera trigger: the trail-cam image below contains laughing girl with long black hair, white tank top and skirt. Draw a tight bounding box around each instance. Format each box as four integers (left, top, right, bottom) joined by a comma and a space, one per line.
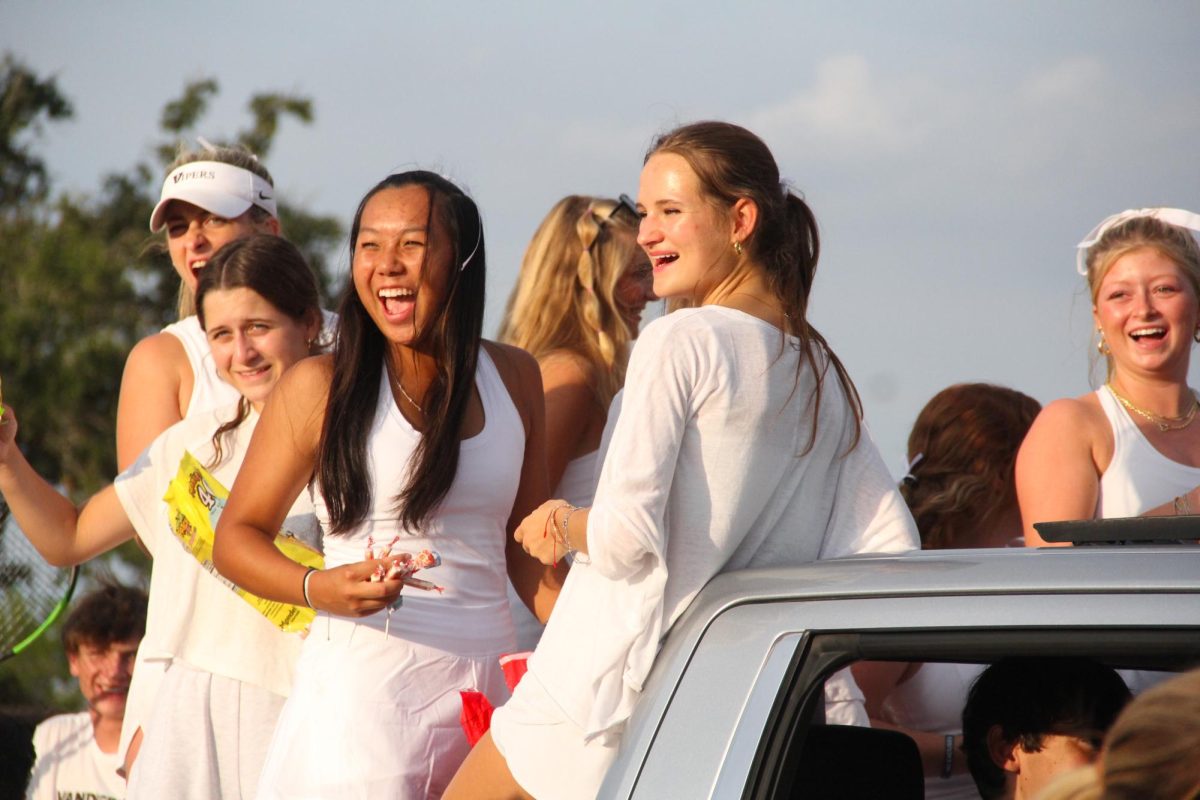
215, 170, 560, 800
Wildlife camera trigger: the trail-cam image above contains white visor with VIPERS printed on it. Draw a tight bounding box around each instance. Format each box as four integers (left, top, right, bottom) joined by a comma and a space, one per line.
150, 161, 280, 231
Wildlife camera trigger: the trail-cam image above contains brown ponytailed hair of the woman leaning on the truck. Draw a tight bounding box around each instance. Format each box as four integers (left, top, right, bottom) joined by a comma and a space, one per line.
646, 121, 863, 452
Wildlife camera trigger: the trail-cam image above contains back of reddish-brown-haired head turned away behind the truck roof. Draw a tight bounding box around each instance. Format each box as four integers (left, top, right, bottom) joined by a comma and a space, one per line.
900, 384, 1042, 549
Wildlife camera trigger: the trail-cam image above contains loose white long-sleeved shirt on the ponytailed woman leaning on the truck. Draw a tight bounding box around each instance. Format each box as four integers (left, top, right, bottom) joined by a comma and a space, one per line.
529, 306, 919, 735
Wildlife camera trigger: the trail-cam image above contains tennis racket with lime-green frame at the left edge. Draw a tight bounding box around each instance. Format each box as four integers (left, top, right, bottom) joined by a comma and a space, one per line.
0, 499, 79, 661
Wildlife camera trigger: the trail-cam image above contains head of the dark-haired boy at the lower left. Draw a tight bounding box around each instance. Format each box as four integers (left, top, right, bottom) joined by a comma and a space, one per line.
62, 584, 146, 726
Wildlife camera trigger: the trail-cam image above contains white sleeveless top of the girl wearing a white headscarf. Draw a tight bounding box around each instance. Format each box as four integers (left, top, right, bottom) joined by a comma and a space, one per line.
1096, 386, 1200, 519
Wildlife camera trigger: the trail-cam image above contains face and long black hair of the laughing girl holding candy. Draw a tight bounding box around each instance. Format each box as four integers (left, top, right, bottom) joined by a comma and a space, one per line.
317, 170, 487, 534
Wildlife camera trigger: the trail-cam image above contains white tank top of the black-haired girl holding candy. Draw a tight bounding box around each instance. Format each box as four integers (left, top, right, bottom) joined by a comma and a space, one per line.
313, 348, 524, 656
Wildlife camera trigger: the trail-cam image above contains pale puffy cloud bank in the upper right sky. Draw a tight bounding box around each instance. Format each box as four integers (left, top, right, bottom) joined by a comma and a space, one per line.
746, 53, 1132, 169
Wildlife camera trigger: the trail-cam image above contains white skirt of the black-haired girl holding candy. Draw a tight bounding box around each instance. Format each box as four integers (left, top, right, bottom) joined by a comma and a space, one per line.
257, 614, 508, 800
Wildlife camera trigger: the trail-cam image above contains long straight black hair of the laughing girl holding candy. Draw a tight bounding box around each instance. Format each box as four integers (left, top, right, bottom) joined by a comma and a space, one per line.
317, 170, 487, 534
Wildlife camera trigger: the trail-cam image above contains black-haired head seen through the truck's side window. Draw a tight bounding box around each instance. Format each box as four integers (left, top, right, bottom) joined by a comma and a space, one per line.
962, 657, 1129, 800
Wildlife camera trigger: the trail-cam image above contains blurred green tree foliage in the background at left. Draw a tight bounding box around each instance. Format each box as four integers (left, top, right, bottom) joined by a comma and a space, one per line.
0, 56, 343, 708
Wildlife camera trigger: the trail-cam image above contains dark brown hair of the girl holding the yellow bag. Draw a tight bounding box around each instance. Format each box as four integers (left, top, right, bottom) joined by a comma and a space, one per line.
196, 234, 322, 468
